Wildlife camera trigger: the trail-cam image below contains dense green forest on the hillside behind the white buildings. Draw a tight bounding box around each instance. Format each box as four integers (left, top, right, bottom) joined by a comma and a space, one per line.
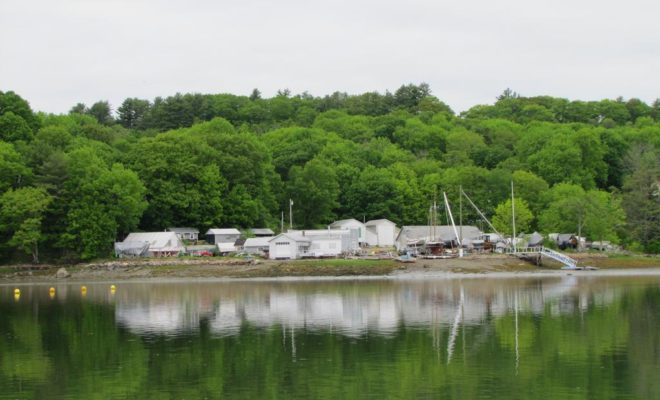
0, 84, 660, 261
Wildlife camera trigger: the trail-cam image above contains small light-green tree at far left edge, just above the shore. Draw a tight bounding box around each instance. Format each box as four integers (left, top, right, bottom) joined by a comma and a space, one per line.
0, 188, 52, 263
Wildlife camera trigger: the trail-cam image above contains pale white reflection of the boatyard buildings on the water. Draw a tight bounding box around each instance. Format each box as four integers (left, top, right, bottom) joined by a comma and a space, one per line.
116, 276, 628, 336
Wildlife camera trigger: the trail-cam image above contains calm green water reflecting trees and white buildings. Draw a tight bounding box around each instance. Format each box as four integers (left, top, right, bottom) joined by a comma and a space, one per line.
0, 276, 660, 399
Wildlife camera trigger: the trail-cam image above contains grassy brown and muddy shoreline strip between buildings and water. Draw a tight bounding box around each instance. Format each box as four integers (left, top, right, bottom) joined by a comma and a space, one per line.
0, 253, 660, 285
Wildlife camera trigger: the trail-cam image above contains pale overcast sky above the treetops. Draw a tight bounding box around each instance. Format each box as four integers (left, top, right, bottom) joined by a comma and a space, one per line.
0, 0, 660, 113
